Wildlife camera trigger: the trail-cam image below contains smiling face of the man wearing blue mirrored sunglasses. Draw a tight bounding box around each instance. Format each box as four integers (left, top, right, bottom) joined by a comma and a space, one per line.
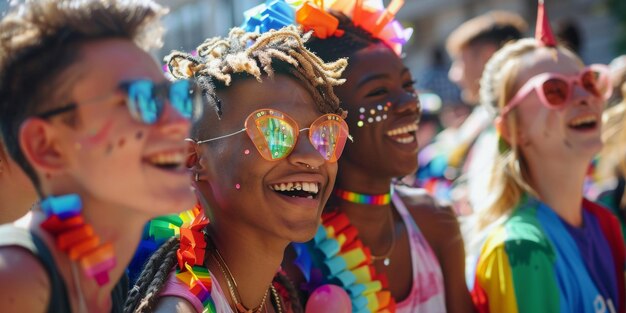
25, 39, 194, 220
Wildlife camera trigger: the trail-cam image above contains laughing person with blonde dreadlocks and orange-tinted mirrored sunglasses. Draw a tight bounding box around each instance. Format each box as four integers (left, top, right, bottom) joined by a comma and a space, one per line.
126, 27, 348, 312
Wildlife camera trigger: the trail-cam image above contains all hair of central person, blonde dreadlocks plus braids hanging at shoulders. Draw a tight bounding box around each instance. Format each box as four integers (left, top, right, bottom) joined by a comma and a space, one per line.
124, 26, 347, 312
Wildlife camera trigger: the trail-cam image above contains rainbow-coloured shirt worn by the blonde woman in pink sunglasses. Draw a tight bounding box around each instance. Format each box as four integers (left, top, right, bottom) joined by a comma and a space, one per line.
472, 197, 626, 313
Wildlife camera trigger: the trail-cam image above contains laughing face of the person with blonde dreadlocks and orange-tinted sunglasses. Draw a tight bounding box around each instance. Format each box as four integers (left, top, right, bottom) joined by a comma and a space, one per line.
196, 74, 337, 242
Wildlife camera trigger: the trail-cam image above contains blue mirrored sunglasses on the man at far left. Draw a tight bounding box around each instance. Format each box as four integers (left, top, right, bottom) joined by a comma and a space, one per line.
37, 79, 202, 125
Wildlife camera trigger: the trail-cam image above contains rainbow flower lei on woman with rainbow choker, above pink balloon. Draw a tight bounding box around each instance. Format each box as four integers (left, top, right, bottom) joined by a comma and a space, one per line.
292, 212, 396, 313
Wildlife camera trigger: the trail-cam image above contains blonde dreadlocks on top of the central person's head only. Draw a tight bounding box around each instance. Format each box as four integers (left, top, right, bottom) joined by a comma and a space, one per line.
165, 26, 348, 138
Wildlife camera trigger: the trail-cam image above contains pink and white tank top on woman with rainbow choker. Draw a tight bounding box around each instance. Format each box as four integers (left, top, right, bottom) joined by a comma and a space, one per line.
391, 192, 446, 313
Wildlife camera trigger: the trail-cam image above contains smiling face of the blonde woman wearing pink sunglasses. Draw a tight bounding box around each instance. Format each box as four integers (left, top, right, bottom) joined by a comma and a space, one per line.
512, 48, 604, 160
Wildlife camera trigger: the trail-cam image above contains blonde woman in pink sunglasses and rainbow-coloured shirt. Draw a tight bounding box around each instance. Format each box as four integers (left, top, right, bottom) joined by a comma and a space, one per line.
473, 0, 626, 312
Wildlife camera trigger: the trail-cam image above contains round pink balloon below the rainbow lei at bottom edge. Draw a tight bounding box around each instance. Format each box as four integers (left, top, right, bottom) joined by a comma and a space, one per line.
304, 284, 352, 313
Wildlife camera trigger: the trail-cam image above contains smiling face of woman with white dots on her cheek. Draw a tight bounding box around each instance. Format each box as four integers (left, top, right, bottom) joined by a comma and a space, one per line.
335, 44, 420, 178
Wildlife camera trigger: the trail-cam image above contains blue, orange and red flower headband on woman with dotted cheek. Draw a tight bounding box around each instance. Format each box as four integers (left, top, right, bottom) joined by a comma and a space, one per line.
242, 0, 413, 55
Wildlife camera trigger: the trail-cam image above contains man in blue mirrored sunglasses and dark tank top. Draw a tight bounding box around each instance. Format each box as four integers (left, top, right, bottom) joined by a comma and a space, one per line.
0, 0, 201, 313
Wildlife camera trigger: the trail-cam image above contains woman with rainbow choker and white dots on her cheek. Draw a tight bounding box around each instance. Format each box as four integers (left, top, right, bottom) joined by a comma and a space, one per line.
262, 1, 473, 312
